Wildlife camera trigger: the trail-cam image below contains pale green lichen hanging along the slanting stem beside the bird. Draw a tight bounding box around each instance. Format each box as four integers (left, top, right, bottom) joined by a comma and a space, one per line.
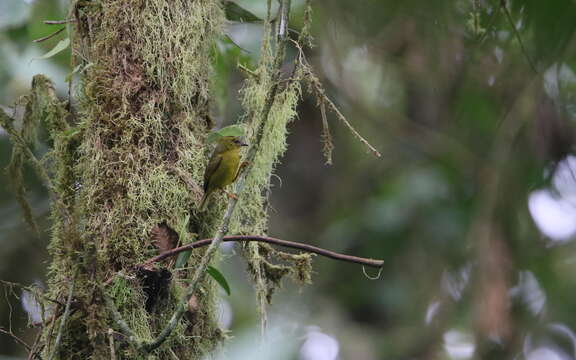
230, 43, 311, 316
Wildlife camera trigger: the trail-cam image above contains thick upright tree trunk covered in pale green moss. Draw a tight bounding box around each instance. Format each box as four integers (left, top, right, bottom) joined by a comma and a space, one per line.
43, 0, 225, 359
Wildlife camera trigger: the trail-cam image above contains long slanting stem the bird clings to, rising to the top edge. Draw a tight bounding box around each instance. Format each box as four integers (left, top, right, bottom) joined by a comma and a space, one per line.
141, 0, 290, 352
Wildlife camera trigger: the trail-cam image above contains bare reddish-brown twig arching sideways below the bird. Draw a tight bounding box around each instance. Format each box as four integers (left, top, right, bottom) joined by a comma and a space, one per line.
141, 235, 384, 268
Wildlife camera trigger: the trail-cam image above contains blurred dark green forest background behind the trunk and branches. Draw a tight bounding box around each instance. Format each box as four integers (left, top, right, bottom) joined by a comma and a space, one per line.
0, 0, 576, 360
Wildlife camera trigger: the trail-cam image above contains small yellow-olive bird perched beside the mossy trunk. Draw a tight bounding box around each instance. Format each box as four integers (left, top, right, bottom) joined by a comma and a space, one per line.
200, 136, 248, 211
